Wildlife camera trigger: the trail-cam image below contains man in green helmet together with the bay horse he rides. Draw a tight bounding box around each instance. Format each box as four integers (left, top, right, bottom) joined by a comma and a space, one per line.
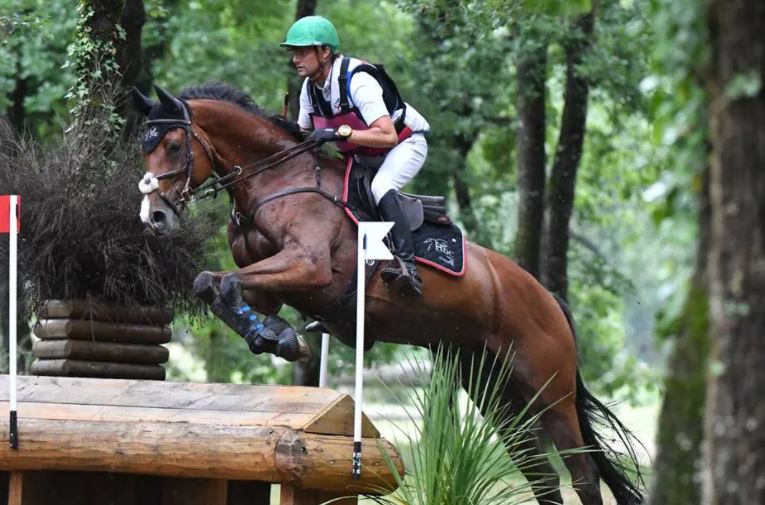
131, 14, 642, 505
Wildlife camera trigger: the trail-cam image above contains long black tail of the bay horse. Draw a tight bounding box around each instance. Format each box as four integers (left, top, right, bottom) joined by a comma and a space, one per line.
555, 295, 645, 505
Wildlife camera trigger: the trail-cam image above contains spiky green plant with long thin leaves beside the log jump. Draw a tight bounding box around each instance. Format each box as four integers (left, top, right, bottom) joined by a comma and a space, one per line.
370, 348, 568, 505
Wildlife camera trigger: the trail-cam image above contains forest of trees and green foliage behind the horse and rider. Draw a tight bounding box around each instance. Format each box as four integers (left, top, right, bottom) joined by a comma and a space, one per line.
0, 0, 765, 503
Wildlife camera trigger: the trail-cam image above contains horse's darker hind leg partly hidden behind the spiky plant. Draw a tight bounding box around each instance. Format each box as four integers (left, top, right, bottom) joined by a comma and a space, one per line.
460, 351, 563, 505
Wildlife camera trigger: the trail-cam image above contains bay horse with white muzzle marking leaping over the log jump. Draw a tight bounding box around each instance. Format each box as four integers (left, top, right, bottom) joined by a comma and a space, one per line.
136, 84, 642, 505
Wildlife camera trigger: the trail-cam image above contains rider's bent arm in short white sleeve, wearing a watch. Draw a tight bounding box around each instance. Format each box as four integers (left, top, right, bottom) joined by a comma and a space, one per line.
349, 72, 398, 147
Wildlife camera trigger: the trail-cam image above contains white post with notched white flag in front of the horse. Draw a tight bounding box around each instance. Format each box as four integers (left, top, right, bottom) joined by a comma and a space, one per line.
353, 222, 393, 480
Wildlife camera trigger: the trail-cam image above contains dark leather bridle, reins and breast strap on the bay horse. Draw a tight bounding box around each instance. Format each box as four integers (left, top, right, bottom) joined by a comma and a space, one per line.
138, 101, 348, 220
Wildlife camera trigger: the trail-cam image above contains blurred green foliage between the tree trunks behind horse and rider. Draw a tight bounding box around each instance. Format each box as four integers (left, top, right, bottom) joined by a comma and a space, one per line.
0, 0, 704, 395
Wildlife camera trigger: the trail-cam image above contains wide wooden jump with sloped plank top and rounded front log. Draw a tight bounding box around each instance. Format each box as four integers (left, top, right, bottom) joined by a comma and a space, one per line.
0, 375, 403, 505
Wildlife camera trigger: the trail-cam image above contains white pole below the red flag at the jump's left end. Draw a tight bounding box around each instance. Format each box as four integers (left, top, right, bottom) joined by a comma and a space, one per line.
8, 195, 19, 449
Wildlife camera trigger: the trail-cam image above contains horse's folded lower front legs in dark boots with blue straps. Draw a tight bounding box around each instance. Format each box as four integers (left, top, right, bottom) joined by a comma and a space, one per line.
194, 272, 310, 361
